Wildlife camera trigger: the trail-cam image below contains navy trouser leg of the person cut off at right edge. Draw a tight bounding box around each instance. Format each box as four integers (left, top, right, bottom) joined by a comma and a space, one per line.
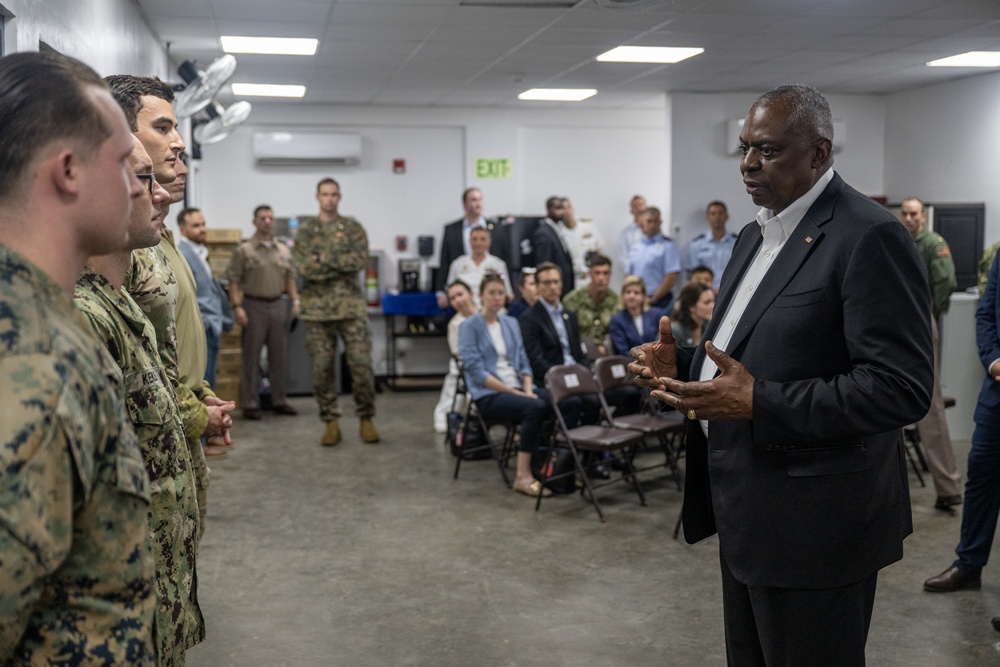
954, 424, 1000, 574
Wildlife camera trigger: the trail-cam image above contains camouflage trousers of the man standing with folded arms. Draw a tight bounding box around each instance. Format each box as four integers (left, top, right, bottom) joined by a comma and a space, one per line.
306, 319, 375, 422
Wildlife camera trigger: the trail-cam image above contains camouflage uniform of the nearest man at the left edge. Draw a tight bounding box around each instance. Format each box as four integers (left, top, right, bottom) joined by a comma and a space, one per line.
0, 247, 156, 665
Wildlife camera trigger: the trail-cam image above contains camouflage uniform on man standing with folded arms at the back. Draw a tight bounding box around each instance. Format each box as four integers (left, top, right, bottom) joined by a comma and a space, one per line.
294, 216, 375, 421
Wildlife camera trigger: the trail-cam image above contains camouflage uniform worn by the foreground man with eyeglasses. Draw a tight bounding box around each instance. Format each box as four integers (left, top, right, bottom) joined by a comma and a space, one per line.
75, 266, 205, 665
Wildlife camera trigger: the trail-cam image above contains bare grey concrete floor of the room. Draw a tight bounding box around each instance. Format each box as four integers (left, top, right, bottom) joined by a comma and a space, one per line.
188, 392, 1000, 667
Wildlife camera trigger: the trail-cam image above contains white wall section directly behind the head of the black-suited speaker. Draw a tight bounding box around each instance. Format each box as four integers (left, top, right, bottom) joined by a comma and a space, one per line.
670, 93, 886, 253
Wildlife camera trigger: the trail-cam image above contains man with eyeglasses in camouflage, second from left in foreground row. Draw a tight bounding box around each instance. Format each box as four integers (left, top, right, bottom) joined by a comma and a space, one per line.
74, 136, 201, 664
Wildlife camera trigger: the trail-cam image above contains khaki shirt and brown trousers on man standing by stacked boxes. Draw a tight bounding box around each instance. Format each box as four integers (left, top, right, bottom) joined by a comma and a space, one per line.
226, 236, 295, 410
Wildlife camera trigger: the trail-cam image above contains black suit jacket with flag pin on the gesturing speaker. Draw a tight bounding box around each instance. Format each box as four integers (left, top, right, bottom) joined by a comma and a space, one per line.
684, 175, 933, 589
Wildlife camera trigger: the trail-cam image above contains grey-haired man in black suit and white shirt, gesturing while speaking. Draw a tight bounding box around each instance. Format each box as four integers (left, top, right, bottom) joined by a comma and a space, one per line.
631, 86, 933, 667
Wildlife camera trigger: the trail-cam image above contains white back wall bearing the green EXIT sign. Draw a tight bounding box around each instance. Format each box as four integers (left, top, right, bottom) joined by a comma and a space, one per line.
192, 98, 669, 290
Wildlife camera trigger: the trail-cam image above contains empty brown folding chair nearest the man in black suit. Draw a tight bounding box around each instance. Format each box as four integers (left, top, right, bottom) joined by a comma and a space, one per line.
594, 355, 685, 490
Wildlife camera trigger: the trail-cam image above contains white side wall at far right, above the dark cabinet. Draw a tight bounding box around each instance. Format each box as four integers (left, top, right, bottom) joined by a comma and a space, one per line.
885, 73, 1000, 245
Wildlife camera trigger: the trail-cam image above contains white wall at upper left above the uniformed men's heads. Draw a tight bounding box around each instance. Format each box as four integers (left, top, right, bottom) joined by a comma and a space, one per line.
0, 0, 168, 78
